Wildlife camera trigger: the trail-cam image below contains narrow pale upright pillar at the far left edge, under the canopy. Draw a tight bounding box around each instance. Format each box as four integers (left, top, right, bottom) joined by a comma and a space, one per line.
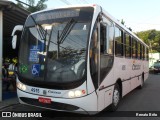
0, 11, 3, 102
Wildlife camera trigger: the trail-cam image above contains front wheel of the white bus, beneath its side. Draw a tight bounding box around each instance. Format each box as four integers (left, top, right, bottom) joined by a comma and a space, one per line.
110, 84, 121, 111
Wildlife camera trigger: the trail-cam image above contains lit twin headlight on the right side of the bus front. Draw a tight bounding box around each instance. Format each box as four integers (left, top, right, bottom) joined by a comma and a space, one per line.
68, 90, 86, 98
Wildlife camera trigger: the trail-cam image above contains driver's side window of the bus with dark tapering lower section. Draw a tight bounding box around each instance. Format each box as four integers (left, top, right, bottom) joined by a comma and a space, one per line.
100, 19, 114, 83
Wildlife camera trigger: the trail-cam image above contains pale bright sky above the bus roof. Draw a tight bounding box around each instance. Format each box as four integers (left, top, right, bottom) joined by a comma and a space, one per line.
10, 0, 160, 32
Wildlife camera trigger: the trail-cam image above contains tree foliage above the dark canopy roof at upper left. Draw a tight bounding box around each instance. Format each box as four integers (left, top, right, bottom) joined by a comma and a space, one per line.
17, 0, 48, 12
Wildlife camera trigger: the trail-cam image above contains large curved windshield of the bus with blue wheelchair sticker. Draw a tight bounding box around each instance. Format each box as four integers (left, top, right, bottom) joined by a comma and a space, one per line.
18, 8, 93, 86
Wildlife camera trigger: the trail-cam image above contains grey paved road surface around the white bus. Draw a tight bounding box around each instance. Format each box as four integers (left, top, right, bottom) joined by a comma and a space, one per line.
0, 74, 160, 120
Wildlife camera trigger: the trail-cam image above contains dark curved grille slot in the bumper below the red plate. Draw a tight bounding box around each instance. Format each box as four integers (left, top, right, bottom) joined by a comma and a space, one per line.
20, 97, 79, 111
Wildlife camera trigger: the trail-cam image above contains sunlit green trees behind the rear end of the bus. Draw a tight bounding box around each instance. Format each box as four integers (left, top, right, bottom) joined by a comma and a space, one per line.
137, 29, 160, 52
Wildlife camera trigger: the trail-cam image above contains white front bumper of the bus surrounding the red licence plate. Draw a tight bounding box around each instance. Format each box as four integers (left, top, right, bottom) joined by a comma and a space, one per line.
17, 89, 97, 114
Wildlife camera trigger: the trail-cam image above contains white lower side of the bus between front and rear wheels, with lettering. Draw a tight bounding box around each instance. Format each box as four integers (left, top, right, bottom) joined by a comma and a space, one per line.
114, 57, 147, 96
